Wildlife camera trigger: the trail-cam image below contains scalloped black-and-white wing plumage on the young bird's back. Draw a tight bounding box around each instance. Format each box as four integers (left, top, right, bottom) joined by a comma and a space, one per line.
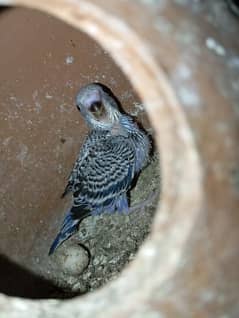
73, 136, 135, 210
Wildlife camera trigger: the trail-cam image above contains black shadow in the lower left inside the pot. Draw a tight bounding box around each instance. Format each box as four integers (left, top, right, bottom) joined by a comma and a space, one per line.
0, 255, 74, 299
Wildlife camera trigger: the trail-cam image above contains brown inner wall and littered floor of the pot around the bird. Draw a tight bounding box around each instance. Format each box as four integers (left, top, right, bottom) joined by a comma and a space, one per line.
0, 8, 159, 298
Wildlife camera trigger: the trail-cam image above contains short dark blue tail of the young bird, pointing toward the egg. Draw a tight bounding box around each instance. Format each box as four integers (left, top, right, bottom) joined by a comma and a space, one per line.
48, 210, 89, 255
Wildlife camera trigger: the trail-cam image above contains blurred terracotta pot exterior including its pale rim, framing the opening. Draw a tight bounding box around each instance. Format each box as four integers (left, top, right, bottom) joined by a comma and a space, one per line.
0, 0, 239, 317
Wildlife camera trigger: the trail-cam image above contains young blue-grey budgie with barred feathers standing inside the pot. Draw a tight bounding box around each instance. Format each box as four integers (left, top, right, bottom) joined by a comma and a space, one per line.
48, 83, 151, 255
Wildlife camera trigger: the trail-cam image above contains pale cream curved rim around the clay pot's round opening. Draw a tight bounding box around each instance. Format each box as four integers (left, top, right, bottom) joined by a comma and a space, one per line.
0, 0, 202, 317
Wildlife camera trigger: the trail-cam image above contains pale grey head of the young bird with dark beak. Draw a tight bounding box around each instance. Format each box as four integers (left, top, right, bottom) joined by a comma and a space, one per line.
76, 83, 120, 129
